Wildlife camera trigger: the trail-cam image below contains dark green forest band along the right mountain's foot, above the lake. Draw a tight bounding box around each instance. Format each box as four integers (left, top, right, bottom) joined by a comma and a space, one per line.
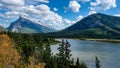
40, 29, 120, 39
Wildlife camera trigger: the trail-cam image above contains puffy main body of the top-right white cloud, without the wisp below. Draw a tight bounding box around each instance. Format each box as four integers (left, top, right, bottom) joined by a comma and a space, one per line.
90, 0, 117, 10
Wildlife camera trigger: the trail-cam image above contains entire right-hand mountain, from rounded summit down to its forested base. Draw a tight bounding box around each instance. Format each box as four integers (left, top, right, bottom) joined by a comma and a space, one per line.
40, 13, 120, 39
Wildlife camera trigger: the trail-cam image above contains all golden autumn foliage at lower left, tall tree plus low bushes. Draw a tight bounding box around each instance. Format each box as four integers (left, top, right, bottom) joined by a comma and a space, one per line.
0, 34, 45, 68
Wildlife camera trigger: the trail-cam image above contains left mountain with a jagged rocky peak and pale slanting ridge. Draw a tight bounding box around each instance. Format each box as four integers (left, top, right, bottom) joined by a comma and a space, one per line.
7, 16, 55, 33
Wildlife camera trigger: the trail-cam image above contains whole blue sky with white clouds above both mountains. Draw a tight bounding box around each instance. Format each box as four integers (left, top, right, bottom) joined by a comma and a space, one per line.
0, 0, 120, 30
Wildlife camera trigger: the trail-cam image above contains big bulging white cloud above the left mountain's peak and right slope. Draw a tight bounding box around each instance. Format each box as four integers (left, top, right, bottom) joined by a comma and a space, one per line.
24, 4, 64, 29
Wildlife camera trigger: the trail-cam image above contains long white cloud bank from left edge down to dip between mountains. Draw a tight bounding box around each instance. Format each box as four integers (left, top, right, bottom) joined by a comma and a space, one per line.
0, 4, 74, 29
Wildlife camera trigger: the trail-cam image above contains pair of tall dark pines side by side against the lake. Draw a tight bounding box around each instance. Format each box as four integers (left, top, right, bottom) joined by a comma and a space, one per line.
57, 40, 71, 68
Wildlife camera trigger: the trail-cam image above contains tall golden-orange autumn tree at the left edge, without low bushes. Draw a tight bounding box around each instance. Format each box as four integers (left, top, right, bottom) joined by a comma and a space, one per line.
0, 34, 19, 68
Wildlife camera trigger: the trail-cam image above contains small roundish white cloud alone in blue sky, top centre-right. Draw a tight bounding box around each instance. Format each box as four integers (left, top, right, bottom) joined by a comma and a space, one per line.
69, 1, 81, 12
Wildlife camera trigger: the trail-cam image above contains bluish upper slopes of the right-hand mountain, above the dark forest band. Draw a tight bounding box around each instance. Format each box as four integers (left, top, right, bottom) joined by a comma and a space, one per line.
63, 13, 120, 32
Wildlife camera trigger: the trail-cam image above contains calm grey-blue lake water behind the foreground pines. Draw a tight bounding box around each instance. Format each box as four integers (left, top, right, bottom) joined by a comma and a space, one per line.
51, 39, 120, 68
